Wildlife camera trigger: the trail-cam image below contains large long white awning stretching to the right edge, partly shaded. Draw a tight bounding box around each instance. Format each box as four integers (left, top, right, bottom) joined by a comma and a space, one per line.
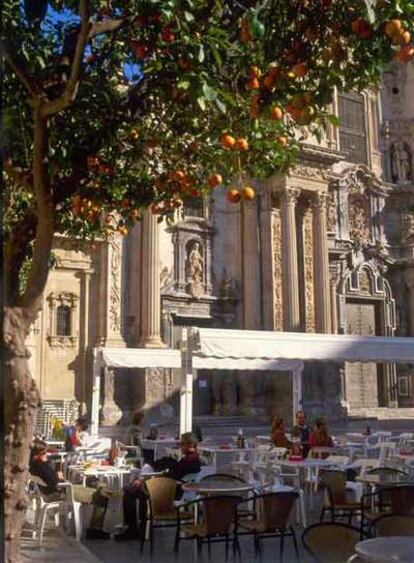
192, 328, 414, 369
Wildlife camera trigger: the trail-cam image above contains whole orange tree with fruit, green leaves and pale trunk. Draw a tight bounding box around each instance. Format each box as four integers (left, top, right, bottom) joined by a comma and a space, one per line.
1, 0, 414, 563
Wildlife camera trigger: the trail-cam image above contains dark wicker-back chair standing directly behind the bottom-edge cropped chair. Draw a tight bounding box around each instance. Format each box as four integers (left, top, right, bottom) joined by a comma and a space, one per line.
320, 470, 361, 524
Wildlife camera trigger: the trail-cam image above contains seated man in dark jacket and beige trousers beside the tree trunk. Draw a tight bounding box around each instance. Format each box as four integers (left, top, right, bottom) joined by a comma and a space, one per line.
29, 442, 112, 539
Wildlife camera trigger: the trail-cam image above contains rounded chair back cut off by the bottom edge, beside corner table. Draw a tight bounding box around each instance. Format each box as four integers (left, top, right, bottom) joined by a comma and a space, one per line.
302, 522, 359, 563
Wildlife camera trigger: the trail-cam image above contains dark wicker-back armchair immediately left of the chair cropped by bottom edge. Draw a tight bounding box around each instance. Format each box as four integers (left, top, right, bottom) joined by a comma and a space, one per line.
236, 491, 299, 558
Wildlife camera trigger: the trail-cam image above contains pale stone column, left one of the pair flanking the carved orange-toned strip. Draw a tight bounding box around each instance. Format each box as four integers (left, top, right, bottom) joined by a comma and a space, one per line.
281, 188, 300, 332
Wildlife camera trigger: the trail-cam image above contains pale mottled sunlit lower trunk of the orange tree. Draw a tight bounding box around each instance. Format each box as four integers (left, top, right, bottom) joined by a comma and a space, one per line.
4, 307, 40, 563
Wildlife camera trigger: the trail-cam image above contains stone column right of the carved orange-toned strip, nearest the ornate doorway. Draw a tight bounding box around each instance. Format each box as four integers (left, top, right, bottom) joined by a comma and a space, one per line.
312, 192, 332, 333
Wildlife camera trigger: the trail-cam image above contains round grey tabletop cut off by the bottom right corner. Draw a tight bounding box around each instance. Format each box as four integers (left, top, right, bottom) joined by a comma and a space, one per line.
355, 536, 414, 563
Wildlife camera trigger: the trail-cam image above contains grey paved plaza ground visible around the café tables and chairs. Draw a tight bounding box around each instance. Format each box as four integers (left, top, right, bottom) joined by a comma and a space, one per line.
22, 419, 414, 563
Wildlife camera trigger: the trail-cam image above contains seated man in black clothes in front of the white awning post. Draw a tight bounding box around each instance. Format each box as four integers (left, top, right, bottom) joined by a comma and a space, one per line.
115, 432, 201, 541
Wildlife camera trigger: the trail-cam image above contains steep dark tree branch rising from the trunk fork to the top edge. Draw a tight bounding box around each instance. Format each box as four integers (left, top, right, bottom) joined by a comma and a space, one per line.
41, 0, 90, 117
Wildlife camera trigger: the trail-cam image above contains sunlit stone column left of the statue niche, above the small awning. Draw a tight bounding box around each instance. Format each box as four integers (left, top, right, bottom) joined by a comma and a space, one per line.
139, 209, 164, 348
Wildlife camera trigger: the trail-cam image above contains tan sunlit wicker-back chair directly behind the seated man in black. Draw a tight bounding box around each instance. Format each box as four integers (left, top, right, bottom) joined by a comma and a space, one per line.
141, 477, 193, 552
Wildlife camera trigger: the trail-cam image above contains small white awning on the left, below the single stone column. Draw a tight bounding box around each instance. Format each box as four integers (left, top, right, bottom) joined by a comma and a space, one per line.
98, 348, 181, 368
